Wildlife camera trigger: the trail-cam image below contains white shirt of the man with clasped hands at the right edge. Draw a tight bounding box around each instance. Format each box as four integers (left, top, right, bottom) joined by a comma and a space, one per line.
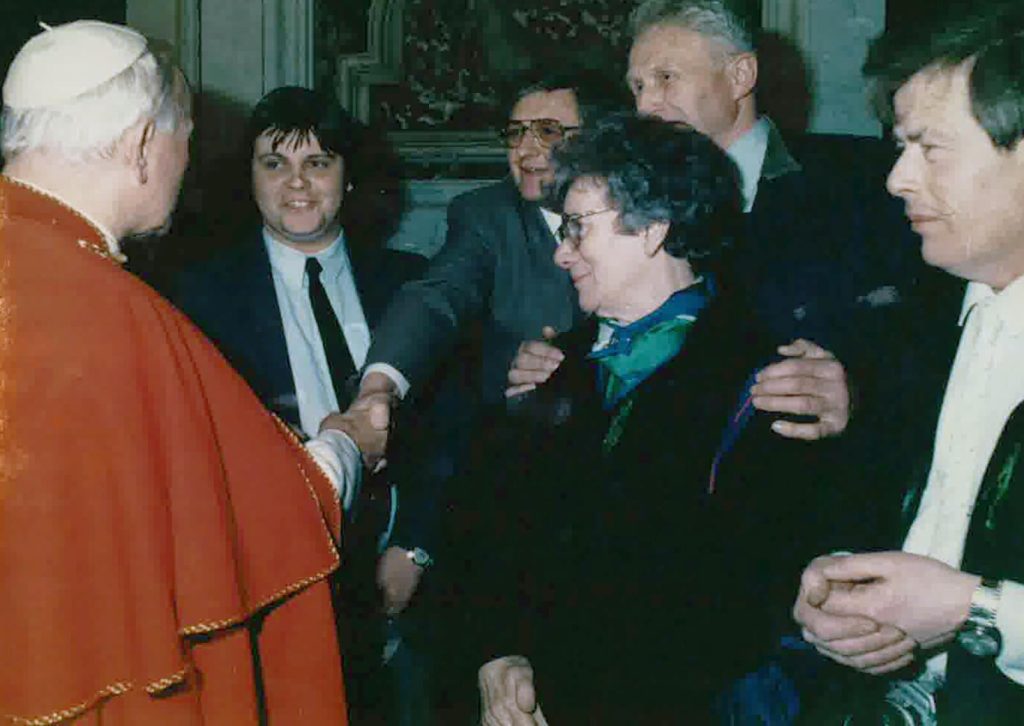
903, 277, 1024, 684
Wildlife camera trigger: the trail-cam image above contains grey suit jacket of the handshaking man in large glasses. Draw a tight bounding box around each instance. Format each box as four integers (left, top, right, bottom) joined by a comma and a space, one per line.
367, 178, 580, 400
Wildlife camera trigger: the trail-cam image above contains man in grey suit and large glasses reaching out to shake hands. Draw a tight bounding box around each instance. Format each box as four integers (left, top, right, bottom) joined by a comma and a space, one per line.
360, 68, 607, 612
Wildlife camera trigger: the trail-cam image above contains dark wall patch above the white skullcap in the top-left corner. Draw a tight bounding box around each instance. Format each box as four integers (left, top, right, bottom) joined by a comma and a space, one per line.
0, 0, 126, 78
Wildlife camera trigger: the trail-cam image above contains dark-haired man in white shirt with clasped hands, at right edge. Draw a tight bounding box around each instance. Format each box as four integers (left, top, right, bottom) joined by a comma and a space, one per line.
794, 2, 1024, 724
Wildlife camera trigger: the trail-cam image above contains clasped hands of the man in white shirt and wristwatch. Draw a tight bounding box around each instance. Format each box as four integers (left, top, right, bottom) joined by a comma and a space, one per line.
793, 552, 981, 675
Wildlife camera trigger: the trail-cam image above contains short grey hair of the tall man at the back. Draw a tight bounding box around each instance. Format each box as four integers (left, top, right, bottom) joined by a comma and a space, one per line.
630, 0, 754, 53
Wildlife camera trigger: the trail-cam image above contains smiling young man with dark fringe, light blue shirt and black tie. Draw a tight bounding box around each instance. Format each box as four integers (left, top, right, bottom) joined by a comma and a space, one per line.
172, 87, 425, 721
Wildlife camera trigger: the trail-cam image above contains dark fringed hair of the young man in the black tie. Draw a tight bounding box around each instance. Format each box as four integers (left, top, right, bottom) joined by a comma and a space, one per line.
246, 86, 366, 178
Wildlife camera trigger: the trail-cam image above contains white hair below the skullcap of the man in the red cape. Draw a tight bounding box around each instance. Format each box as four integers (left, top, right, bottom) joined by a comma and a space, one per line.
0, 50, 188, 162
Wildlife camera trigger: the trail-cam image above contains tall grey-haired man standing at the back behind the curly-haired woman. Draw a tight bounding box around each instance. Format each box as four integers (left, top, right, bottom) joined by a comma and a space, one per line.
627, 0, 920, 435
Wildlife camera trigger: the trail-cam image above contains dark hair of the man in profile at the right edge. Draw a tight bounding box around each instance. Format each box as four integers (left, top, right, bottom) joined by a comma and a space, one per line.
864, 0, 1024, 148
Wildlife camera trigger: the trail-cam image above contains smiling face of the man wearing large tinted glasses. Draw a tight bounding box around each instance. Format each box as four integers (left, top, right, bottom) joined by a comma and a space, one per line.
508, 89, 580, 201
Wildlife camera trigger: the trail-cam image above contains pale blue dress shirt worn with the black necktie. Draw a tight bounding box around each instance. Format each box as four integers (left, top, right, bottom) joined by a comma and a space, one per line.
263, 229, 370, 436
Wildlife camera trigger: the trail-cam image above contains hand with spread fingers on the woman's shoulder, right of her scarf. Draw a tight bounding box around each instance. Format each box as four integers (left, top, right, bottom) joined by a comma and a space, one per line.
751, 338, 850, 440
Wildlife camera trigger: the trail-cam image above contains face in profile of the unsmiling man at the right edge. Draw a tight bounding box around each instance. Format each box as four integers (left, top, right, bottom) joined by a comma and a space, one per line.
888, 65, 1024, 289
